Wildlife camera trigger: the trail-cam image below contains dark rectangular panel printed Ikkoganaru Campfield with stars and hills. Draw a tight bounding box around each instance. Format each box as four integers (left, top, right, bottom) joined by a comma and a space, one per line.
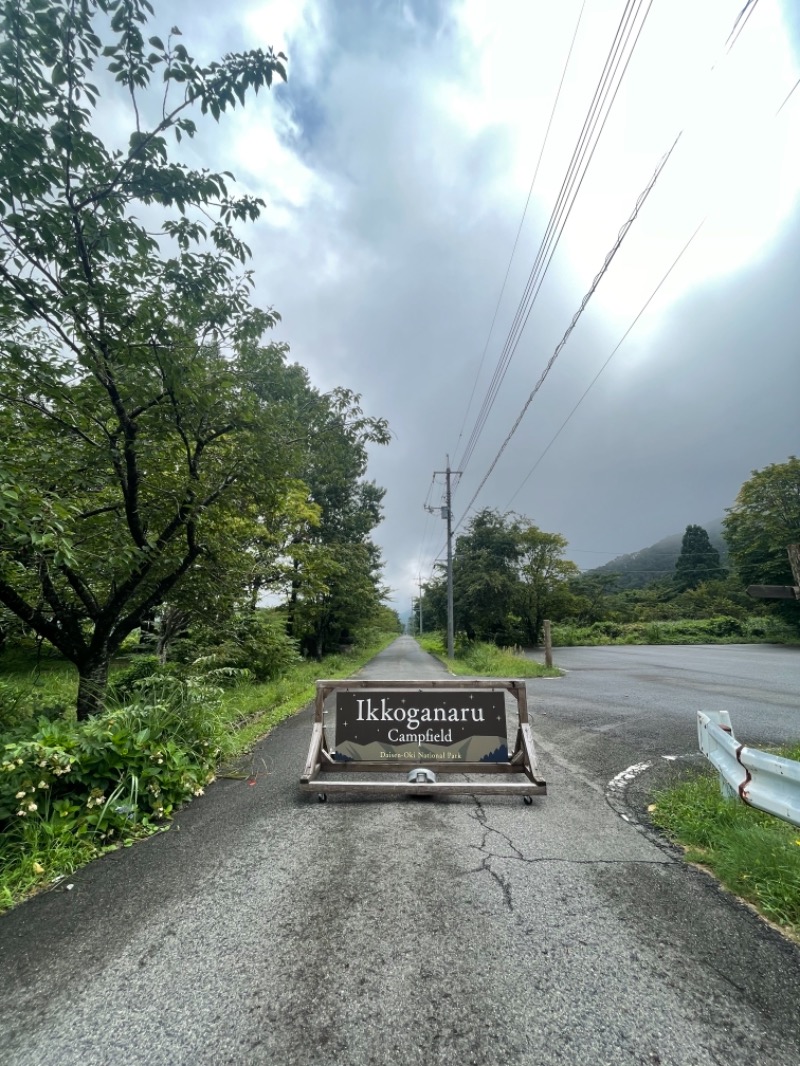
335, 689, 509, 762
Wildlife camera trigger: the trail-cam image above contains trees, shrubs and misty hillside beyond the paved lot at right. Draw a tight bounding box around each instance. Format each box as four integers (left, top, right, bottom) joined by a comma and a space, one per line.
411, 456, 800, 648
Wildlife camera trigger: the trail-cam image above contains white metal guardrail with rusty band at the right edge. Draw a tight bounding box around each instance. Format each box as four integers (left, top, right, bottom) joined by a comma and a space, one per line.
698, 711, 800, 825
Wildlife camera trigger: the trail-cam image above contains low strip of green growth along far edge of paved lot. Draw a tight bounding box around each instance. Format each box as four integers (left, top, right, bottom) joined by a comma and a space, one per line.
553, 615, 800, 647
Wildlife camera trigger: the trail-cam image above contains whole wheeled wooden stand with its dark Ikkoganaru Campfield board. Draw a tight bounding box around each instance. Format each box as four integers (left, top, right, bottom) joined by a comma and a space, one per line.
301, 678, 547, 803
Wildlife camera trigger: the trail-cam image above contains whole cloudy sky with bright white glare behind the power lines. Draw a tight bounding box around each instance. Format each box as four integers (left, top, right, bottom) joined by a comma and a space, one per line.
155, 0, 800, 613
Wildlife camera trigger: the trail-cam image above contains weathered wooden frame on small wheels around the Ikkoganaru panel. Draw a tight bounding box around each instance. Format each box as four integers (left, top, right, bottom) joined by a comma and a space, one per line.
300, 678, 547, 804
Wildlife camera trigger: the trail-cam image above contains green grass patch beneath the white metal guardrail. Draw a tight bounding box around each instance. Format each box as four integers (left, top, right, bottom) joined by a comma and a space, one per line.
650, 745, 800, 939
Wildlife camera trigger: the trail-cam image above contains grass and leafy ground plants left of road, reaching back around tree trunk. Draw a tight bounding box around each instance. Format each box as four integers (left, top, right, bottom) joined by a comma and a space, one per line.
0, 628, 397, 912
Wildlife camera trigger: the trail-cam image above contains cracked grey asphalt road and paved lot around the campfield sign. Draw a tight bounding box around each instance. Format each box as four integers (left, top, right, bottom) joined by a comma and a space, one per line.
0, 637, 800, 1066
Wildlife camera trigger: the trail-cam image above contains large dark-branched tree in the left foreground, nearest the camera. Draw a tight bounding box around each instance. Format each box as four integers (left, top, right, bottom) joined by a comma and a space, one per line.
0, 0, 298, 717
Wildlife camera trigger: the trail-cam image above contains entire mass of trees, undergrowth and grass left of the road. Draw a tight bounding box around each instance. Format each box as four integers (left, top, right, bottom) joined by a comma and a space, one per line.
0, 0, 400, 905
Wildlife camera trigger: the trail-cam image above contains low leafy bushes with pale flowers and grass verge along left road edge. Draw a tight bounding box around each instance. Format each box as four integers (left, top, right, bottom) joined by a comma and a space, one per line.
0, 632, 396, 911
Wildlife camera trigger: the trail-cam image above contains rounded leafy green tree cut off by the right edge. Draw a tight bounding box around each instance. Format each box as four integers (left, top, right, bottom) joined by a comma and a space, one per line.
723, 455, 800, 618
